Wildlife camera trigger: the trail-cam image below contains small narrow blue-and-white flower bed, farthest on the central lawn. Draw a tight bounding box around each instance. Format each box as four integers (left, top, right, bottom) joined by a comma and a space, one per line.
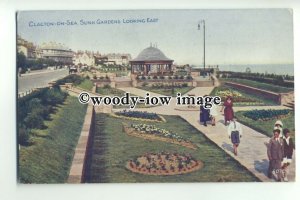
112, 110, 166, 122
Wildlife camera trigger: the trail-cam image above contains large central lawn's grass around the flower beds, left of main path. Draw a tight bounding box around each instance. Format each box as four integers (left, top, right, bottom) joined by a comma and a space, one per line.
87, 114, 258, 183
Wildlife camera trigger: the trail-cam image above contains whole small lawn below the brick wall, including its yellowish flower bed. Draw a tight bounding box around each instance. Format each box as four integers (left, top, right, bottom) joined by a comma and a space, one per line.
210, 85, 276, 106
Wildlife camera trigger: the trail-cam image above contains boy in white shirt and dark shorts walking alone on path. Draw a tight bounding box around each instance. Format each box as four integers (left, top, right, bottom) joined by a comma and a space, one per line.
227, 117, 243, 156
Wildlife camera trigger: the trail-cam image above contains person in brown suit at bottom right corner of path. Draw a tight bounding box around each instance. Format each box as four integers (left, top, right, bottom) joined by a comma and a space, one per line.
267, 128, 283, 181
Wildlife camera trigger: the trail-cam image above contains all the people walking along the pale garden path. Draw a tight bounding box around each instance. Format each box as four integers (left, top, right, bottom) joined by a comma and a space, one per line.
200, 97, 295, 181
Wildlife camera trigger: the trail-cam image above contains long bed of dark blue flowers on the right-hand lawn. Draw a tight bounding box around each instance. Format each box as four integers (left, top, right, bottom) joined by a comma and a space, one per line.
243, 109, 290, 121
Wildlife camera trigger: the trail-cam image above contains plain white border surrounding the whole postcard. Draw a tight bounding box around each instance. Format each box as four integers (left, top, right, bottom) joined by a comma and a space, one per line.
0, 0, 300, 200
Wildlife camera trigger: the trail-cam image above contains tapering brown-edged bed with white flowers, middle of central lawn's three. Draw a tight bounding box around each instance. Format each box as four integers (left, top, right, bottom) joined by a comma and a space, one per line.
124, 124, 197, 149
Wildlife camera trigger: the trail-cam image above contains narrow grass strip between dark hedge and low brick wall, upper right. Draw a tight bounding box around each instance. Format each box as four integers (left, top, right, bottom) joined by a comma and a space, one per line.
221, 78, 294, 93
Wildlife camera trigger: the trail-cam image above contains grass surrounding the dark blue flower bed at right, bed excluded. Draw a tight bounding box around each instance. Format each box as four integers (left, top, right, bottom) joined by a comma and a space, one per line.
235, 111, 295, 141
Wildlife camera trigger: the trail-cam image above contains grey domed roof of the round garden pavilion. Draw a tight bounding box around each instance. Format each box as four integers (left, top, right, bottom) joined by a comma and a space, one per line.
131, 46, 173, 61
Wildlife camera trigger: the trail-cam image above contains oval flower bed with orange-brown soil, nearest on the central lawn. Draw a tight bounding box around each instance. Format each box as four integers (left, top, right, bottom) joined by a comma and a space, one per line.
126, 152, 203, 175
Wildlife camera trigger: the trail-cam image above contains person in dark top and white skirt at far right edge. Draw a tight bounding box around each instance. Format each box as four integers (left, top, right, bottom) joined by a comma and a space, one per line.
282, 128, 295, 181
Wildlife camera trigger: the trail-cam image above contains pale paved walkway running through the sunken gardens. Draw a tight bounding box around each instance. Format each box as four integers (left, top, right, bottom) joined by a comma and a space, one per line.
116, 87, 295, 182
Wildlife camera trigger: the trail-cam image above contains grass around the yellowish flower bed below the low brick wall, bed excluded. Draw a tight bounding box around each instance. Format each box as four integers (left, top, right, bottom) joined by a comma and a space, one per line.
210, 85, 277, 106
